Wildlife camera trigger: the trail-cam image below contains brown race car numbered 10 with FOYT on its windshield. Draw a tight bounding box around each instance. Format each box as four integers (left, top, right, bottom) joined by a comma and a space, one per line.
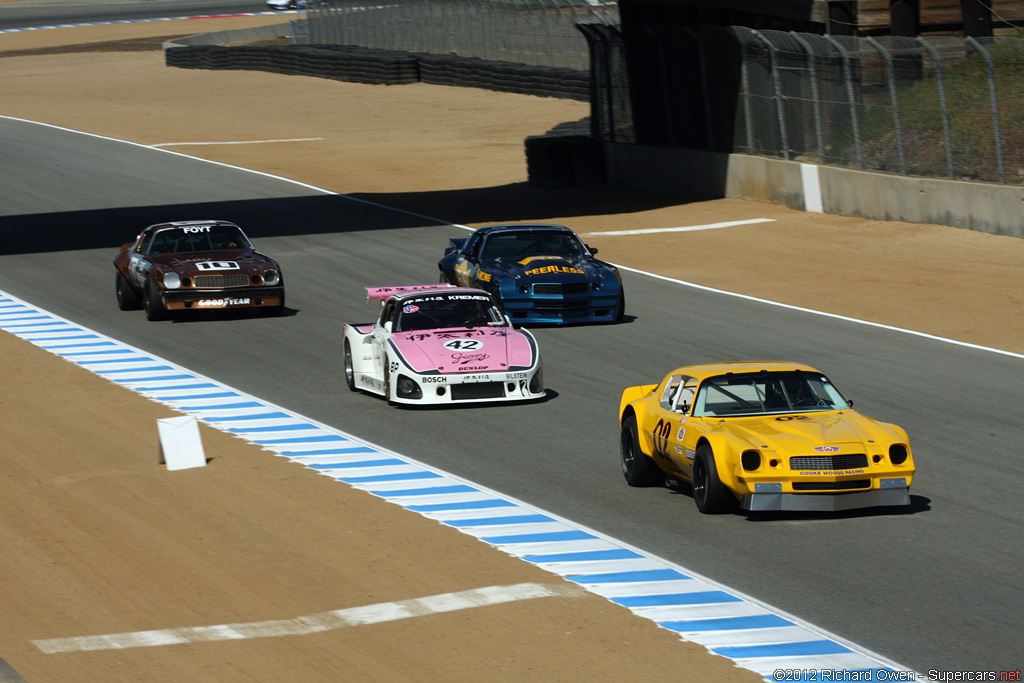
114, 220, 285, 321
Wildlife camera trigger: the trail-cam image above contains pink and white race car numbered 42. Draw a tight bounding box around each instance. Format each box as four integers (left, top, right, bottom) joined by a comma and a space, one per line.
345, 285, 545, 404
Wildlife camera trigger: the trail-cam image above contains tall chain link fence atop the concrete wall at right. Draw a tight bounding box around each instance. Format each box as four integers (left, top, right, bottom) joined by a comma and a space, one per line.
587, 27, 1024, 184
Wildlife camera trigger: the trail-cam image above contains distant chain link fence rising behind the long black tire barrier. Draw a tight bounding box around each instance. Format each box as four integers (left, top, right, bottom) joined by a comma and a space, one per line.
305, 0, 618, 71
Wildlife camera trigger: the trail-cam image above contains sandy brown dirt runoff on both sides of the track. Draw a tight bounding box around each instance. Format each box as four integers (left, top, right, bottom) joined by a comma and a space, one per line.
0, 16, 1024, 683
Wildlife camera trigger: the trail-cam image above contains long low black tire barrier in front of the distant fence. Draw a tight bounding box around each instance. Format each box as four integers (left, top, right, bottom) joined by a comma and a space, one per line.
164, 45, 590, 101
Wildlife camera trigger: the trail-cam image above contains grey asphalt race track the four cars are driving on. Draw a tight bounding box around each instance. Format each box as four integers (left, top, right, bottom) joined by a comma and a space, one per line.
0, 119, 1024, 672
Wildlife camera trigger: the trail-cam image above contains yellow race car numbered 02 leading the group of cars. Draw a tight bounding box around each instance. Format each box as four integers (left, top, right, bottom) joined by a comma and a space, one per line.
618, 361, 914, 513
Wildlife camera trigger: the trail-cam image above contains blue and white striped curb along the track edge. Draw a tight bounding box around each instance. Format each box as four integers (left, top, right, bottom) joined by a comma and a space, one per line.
0, 291, 924, 681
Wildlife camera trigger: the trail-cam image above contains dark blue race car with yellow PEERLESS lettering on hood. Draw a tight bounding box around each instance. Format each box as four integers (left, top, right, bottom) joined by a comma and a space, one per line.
437, 224, 626, 325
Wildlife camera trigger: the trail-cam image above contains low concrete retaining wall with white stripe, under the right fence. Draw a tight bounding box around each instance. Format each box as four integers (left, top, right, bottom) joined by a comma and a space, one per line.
604, 143, 1024, 238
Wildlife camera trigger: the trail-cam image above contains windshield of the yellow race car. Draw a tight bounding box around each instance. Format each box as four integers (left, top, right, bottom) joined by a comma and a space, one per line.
693, 371, 850, 417
